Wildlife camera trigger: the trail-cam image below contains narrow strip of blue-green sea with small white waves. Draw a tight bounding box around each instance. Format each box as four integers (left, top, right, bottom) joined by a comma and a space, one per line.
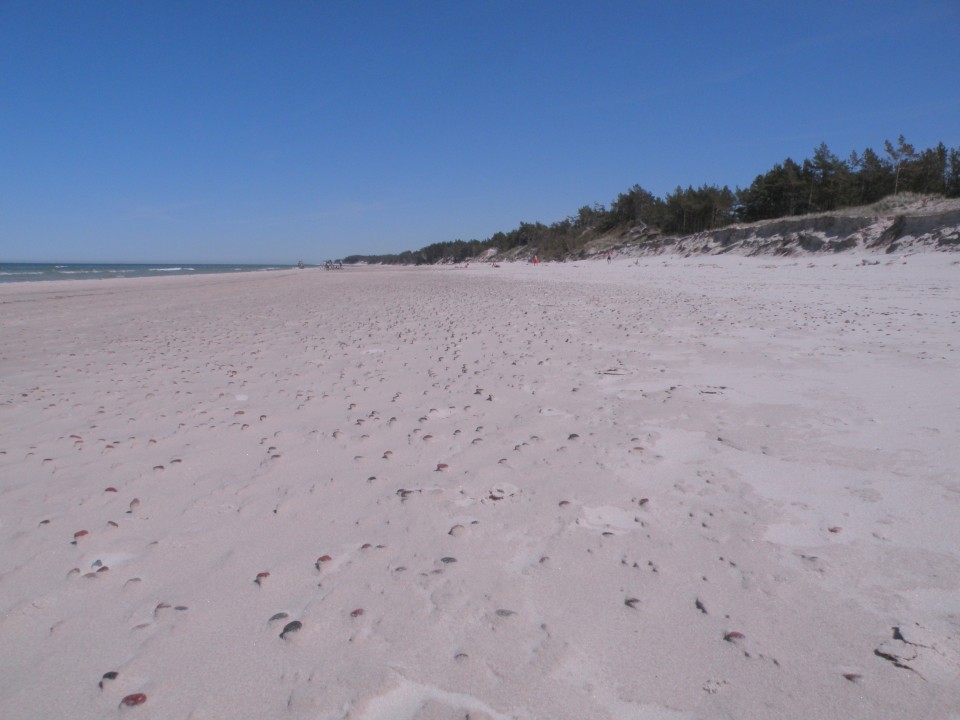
0, 263, 296, 283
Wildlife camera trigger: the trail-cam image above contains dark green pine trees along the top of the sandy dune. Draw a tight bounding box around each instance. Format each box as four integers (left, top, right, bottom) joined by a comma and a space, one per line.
343, 135, 960, 265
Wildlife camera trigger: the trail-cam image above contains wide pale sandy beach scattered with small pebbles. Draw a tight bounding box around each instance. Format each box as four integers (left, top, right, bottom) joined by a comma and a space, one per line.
0, 253, 960, 720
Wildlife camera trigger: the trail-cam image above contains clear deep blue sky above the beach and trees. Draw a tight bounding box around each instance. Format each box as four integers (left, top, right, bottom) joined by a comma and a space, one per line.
0, 0, 960, 263
